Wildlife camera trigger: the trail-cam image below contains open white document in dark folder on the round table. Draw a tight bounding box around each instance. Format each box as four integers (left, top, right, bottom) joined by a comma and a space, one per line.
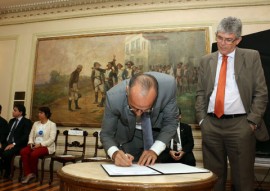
101, 163, 209, 176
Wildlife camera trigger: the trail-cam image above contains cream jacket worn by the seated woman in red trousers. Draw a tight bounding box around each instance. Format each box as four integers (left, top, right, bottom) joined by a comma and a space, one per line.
28, 120, 56, 154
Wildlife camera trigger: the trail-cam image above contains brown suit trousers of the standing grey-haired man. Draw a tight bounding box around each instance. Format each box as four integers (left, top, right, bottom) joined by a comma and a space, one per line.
201, 116, 256, 191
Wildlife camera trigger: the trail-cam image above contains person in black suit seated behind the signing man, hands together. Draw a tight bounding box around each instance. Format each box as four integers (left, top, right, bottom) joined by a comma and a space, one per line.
159, 107, 196, 166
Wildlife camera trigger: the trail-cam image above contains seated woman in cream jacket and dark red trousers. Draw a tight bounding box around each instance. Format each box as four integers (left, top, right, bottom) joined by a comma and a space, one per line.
20, 107, 56, 184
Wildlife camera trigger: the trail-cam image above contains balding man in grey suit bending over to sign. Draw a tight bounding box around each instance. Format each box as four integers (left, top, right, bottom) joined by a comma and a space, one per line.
100, 72, 178, 166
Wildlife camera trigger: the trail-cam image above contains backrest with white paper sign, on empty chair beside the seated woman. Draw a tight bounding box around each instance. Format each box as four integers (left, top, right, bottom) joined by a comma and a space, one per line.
63, 128, 88, 157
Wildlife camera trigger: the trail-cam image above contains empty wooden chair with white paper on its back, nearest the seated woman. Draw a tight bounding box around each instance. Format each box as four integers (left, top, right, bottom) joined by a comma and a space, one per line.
49, 128, 88, 185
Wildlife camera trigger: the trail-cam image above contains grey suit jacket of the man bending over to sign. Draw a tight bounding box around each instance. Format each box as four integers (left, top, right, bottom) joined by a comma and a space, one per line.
100, 72, 178, 151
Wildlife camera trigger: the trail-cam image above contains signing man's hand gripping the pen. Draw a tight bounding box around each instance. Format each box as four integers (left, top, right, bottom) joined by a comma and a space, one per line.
112, 150, 134, 166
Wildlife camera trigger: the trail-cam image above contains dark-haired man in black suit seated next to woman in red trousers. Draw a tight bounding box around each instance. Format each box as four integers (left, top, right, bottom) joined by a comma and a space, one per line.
2, 104, 32, 178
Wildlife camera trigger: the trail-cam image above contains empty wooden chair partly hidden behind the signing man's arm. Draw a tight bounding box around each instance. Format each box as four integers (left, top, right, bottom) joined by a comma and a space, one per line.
82, 131, 111, 162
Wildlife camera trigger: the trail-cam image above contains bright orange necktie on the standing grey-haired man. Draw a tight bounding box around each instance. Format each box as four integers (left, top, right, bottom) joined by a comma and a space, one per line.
214, 55, 228, 118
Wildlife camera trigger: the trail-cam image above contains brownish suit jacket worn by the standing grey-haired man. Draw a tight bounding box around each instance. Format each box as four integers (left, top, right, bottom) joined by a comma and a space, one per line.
195, 47, 268, 128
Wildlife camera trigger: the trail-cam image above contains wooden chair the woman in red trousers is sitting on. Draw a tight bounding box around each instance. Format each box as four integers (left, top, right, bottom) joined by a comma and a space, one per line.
18, 130, 60, 185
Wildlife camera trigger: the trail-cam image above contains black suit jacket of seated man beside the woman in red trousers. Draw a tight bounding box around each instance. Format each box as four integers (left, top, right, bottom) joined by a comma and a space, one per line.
6, 117, 32, 148
